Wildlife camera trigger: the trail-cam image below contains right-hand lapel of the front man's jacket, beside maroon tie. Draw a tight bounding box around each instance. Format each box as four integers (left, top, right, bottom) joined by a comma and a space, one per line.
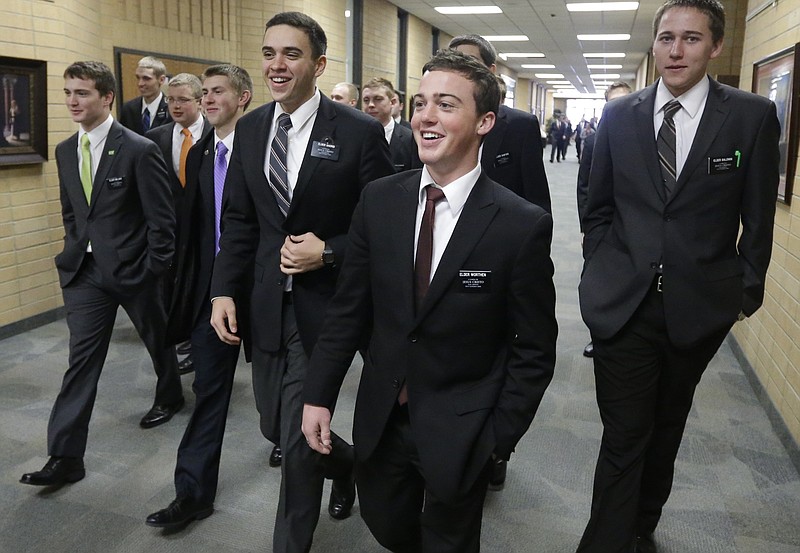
412, 173, 499, 321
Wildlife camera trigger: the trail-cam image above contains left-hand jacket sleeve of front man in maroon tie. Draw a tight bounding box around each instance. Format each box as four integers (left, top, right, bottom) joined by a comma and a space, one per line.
303, 188, 376, 411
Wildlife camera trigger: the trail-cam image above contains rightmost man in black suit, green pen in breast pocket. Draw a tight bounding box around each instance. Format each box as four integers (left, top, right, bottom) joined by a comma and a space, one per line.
578, 0, 780, 553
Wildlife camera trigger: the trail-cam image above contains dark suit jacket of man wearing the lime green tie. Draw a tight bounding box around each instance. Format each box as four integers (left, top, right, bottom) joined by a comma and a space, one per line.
55, 121, 175, 293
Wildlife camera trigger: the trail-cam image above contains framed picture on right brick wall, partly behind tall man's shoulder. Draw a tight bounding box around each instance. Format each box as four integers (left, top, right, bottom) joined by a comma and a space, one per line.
753, 43, 800, 204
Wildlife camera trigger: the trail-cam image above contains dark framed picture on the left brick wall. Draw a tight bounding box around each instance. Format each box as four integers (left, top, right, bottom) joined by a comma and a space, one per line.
0, 56, 47, 165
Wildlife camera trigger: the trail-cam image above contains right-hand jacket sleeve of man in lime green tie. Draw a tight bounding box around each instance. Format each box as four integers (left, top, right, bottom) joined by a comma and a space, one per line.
136, 138, 176, 275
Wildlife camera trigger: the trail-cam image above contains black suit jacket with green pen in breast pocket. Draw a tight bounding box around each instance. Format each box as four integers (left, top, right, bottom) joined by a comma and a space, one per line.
580, 79, 780, 347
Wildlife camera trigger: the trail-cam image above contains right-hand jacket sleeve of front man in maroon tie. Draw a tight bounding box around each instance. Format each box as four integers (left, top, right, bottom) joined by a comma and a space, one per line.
492, 209, 558, 459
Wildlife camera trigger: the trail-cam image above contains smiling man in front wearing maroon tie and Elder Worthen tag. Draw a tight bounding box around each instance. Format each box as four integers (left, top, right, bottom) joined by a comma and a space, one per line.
303, 50, 557, 553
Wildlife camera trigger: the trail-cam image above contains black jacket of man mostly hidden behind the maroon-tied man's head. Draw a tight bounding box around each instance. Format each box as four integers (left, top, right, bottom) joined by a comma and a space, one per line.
481, 106, 551, 213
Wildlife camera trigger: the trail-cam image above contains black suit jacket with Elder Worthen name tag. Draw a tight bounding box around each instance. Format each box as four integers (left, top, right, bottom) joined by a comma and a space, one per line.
303, 171, 557, 501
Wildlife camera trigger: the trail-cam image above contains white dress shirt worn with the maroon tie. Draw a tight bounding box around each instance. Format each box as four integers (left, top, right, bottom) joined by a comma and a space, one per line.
414, 163, 481, 280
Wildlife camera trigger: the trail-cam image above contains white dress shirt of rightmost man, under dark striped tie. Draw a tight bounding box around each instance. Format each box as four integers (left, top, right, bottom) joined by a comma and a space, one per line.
653, 77, 709, 177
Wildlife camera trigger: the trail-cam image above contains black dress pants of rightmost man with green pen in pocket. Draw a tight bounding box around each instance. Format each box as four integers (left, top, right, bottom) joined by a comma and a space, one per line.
578, 279, 729, 553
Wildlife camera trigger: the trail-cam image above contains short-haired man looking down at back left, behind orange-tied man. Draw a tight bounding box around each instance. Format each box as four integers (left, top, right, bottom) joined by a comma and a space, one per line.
119, 56, 172, 135
